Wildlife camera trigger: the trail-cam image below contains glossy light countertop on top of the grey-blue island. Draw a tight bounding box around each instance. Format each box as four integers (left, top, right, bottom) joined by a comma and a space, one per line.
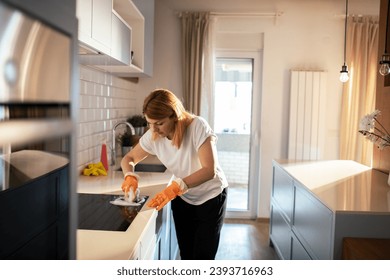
274, 160, 390, 214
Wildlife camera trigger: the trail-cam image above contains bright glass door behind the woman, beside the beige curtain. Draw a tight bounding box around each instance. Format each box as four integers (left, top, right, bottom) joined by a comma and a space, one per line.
213, 52, 260, 218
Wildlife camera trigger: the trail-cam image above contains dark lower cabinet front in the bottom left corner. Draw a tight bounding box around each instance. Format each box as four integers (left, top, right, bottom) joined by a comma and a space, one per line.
0, 166, 69, 260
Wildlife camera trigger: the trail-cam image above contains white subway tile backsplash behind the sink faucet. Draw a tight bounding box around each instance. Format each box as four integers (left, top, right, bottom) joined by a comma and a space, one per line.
77, 65, 141, 171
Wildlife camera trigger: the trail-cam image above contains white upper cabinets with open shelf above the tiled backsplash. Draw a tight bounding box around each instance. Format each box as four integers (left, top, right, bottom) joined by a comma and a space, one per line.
77, 0, 155, 77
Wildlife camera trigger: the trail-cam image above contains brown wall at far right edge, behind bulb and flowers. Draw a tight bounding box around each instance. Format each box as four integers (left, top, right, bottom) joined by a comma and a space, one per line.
373, 0, 390, 172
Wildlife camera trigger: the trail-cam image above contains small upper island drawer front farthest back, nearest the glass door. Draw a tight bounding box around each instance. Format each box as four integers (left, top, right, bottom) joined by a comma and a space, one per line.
272, 166, 294, 223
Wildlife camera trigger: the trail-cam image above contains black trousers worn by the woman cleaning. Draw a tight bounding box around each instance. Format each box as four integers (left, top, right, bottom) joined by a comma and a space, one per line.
171, 188, 227, 260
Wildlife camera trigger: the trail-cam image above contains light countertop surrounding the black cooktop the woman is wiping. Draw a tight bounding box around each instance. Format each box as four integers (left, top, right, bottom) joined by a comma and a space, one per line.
77, 168, 171, 260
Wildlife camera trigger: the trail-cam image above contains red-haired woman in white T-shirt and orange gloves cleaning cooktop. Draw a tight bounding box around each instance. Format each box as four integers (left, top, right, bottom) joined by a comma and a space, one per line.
121, 89, 227, 260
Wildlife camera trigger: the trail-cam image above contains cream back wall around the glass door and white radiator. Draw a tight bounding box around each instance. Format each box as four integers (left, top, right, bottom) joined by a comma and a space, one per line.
138, 0, 379, 217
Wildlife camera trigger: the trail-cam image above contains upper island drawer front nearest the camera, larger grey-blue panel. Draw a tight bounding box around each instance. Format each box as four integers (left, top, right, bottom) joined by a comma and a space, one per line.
293, 186, 333, 260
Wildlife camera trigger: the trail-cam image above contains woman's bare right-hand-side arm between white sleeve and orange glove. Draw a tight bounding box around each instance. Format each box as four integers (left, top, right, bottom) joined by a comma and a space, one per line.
182, 136, 217, 188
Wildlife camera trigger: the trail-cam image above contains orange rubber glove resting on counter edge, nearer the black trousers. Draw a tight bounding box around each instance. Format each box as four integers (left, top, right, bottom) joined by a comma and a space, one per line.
148, 179, 188, 210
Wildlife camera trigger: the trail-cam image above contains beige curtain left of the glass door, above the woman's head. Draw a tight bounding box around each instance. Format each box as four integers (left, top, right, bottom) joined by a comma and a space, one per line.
180, 12, 210, 115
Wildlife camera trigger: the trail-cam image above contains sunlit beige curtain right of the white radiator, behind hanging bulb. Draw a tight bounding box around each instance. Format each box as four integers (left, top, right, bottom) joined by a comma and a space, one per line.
340, 16, 379, 166
